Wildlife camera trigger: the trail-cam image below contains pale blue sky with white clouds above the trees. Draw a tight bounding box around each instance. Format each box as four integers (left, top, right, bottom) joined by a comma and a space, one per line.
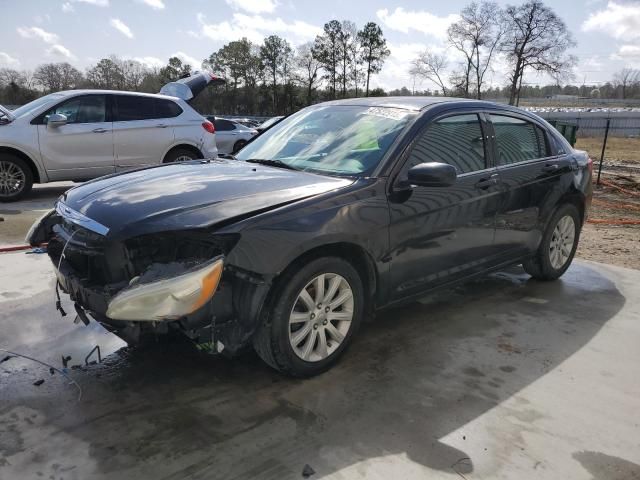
0, 0, 640, 89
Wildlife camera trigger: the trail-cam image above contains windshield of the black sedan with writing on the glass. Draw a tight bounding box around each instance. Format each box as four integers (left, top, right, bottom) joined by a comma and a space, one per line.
237, 105, 415, 176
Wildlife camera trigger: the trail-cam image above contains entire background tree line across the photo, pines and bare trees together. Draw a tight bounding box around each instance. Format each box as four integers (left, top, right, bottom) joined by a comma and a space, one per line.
0, 0, 640, 115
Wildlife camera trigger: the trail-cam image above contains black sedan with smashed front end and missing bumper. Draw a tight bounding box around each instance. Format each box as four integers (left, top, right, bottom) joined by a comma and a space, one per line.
29, 97, 592, 376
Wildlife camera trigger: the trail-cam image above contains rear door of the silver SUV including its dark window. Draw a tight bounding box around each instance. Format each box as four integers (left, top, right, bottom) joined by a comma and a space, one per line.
113, 95, 182, 170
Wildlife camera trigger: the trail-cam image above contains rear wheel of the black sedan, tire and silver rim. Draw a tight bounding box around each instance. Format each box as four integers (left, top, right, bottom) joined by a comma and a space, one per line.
522, 204, 581, 280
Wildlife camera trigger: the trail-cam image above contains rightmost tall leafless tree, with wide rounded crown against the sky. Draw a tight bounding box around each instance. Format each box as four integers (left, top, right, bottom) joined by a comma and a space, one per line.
500, 0, 576, 105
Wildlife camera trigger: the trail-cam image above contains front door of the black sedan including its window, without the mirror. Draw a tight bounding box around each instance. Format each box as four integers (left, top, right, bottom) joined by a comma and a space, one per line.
389, 113, 501, 301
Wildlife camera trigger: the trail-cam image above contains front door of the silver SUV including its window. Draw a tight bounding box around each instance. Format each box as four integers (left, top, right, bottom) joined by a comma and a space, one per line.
33, 94, 114, 180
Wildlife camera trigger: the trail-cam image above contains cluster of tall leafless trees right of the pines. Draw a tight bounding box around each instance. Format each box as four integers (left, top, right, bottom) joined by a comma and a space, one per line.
410, 0, 577, 105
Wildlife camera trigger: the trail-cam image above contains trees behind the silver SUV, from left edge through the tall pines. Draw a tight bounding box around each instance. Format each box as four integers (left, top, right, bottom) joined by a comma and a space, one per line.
0, 20, 390, 115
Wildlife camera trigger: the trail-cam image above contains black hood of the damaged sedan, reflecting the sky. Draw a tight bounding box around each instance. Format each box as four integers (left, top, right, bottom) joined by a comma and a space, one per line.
60, 159, 353, 239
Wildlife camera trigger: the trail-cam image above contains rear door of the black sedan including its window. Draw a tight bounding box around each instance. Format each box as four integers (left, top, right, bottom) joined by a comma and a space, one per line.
488, 112, 572, 258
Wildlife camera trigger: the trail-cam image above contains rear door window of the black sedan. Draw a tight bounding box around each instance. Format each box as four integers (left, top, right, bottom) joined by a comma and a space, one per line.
491, 114, 548, 165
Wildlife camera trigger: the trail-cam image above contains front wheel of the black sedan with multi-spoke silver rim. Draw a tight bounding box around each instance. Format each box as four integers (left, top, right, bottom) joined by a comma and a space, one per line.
253, 257, 364, 377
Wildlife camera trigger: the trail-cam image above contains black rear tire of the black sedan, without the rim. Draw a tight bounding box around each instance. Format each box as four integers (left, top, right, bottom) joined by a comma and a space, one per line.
522, 204, 582, 281
